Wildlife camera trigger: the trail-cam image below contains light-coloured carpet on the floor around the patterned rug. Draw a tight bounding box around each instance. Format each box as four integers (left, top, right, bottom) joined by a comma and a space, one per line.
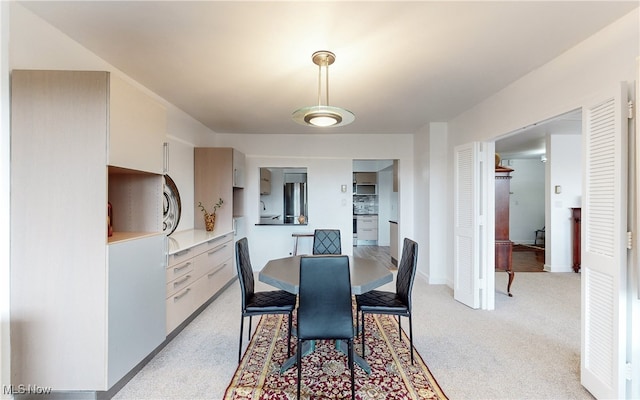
114, 271, 593, 400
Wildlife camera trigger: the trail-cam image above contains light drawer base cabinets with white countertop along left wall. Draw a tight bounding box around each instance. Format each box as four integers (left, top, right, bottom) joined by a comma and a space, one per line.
165, 231, 236, 335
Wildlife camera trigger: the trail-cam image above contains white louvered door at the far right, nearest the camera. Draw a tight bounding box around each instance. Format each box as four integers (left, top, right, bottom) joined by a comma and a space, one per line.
580, 84, 628, 399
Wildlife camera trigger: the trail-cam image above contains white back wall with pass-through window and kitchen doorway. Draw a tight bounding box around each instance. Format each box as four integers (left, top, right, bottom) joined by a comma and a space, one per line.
214, 133, 414, 270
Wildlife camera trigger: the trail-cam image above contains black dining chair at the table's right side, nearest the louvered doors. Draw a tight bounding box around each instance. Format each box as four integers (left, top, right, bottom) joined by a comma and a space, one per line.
356, 238, 418, 364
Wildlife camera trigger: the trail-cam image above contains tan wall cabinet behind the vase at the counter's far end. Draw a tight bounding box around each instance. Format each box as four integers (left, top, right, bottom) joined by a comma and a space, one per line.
193, 147, 245, 232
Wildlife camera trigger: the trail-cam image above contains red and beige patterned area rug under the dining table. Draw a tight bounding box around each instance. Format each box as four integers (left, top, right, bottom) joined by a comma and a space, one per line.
224, 314, 447, 400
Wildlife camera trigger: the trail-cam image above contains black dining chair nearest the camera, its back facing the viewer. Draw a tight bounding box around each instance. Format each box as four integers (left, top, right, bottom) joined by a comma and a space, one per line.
296, 255, 355, 399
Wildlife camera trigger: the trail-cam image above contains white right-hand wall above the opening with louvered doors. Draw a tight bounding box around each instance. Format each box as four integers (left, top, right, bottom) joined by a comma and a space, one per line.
446, 9, 640, 279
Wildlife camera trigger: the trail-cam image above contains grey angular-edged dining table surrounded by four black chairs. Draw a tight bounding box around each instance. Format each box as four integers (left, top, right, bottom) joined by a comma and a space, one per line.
258, 255, 393, 374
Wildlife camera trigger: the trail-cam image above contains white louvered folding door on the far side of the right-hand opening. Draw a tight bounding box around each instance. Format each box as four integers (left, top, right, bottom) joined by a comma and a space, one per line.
453, 142, 494, 309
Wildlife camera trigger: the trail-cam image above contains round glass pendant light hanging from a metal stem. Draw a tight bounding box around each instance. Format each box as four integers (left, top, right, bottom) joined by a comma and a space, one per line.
292, 50, 356, 127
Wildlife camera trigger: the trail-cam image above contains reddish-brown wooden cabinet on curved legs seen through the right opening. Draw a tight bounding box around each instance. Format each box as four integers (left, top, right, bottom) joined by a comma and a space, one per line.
495, 166, 514, 296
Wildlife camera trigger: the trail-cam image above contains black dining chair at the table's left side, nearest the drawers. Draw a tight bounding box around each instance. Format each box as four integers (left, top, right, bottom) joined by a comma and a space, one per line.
236, 238, 297, 362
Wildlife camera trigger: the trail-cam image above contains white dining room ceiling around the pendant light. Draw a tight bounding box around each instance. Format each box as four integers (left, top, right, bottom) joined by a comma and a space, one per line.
17, 0, 638, 141
